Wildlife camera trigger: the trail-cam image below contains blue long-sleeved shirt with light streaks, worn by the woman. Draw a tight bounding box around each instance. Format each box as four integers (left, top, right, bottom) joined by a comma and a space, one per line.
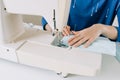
42, 0, 120, 42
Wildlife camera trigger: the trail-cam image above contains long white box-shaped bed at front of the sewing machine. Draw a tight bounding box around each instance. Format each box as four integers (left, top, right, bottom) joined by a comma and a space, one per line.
17, 41, 102, 76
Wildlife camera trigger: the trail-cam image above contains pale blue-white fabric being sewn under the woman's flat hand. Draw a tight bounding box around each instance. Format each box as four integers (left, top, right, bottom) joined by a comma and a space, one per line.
61, 35, 116, 56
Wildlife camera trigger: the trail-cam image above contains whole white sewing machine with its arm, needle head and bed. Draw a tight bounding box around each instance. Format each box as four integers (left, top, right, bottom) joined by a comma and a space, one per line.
0, 0, 102, 77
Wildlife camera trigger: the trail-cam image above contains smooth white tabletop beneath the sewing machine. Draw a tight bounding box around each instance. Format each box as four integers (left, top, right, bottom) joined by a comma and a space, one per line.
0, 55, 120, 80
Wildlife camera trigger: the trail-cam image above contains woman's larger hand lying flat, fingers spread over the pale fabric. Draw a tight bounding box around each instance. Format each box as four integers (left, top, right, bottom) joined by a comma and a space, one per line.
68, 24, 102, 47
